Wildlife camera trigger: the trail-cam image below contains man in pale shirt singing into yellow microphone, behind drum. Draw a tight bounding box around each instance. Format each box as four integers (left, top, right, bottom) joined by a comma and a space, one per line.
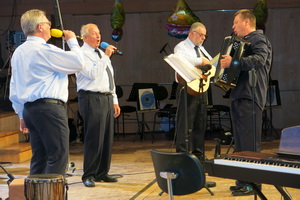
9, 9, 83, 175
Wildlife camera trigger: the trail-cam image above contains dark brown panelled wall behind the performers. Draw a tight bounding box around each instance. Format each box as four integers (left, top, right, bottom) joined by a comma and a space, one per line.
0, 0, 300, 128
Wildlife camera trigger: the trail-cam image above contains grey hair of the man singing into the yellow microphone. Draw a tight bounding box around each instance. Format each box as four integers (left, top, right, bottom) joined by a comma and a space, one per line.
21, 9, 46, 35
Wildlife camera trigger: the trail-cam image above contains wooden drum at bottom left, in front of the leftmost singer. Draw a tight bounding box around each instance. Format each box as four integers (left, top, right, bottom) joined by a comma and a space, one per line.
24, 174, 67, 200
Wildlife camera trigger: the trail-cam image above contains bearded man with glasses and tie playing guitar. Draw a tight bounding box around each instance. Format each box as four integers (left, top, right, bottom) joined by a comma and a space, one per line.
174, 22, 214, 186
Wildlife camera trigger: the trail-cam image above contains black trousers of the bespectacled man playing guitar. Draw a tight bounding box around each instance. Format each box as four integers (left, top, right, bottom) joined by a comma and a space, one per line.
175, 84, 207, 159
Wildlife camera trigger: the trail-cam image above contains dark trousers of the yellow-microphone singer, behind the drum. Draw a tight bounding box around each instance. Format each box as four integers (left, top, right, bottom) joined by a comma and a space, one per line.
23, 101, 70, 175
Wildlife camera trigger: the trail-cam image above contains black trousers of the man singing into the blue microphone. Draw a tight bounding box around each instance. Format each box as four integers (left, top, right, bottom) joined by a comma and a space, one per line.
78, 90, 114, 180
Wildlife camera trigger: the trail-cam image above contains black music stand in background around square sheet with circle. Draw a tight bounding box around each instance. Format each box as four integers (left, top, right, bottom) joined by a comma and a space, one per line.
126, 83, 158, 140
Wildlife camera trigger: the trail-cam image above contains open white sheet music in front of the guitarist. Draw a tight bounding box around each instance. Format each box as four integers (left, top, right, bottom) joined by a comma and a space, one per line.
164, 54, 202, 83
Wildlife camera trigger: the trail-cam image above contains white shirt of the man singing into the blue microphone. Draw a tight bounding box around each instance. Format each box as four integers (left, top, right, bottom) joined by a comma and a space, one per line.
76, 43, 118, 104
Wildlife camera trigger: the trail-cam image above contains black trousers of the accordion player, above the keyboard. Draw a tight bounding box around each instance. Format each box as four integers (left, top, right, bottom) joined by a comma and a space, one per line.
231, 99, 262, 152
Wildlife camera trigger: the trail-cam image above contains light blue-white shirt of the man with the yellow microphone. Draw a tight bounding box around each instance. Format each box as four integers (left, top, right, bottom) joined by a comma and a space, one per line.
9, 36, 83, 119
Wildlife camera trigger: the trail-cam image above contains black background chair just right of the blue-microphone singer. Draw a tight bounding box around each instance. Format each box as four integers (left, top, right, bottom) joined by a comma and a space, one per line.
116, 85, 139, 138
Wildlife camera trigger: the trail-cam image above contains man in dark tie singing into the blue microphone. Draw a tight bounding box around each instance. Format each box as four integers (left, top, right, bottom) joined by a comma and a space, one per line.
76, 24, 120, 187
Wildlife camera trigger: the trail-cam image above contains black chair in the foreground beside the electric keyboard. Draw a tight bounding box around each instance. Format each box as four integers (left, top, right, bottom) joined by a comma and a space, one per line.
150, 150, 205, 200
